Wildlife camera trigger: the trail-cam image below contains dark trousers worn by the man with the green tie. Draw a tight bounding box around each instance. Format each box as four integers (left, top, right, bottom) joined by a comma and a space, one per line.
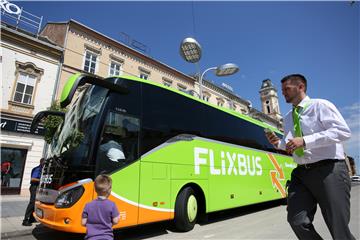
287, 160, 355, 240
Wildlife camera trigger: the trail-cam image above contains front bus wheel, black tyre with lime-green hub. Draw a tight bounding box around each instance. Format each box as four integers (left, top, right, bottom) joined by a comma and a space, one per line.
175, 187, 199, 232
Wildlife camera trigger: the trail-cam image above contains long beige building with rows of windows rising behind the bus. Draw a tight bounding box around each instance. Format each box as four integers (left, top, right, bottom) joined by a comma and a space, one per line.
41, 20, 258, 117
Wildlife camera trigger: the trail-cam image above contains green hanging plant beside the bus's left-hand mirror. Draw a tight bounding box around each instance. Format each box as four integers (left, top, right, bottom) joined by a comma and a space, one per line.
44, 102, 66, 143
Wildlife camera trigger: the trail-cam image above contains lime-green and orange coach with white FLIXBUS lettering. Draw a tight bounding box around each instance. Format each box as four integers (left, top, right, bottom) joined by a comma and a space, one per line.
32, 74, 296, 233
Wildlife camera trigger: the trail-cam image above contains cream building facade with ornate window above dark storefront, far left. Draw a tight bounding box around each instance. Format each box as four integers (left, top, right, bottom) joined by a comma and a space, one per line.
0, 22, 62, 195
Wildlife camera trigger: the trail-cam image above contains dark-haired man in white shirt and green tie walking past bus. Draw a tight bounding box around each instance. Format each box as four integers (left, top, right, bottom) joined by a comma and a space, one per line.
266, 74, 355, 239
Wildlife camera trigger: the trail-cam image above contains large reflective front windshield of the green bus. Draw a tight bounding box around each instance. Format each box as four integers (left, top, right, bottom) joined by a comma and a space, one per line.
40, 86, 109, 189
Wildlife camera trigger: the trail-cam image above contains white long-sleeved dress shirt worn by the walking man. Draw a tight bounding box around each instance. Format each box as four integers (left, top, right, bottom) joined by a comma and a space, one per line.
279, 96, 351, 164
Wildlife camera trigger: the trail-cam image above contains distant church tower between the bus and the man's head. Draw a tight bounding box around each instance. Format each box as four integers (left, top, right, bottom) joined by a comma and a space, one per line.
259, 79, 282, 121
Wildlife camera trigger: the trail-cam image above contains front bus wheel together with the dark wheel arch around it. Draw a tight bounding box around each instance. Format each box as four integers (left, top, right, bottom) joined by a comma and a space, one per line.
174, 183, 206, 232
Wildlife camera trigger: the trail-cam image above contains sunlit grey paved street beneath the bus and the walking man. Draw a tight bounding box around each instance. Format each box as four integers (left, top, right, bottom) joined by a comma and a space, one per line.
2, 184, 360, 240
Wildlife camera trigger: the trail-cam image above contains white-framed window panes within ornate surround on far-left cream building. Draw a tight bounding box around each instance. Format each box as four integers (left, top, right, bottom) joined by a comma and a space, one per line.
13, 72, 36, 104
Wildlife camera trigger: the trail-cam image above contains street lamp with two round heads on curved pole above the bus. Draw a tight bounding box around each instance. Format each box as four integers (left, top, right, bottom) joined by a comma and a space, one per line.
180, 38, 239, 99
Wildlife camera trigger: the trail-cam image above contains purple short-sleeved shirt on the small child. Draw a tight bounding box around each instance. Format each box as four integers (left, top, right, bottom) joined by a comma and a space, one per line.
82, 198, 119, 240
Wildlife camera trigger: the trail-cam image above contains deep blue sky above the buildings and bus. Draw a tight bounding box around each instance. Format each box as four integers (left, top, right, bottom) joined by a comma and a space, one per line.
5, 1, 360, 168
